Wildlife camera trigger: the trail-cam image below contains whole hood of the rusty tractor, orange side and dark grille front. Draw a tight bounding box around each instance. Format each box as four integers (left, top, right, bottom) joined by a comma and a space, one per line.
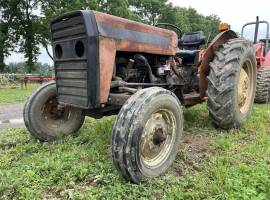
51, 10, 178, 108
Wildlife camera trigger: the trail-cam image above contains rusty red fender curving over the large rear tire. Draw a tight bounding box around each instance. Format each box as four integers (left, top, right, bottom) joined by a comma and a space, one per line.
199, 30, 237, 99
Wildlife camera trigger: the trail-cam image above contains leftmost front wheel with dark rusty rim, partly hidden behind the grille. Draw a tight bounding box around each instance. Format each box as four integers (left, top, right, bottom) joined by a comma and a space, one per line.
23, 81, 84, 141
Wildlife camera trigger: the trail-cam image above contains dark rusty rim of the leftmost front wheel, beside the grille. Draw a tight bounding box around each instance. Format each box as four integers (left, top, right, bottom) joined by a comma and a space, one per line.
41, 96, 72, 128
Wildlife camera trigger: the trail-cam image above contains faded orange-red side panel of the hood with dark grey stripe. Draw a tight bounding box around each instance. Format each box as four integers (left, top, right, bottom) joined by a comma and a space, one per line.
94, 11, 178, 103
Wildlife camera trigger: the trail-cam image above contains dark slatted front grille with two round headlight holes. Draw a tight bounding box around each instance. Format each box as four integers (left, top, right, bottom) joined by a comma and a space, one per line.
51, 15, 88, 108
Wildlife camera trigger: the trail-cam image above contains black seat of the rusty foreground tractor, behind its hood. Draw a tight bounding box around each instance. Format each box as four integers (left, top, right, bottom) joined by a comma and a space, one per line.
179, 31, 206, 50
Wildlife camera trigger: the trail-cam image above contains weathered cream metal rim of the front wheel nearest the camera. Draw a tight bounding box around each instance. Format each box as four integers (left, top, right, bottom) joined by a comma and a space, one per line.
140, 109, 176, 168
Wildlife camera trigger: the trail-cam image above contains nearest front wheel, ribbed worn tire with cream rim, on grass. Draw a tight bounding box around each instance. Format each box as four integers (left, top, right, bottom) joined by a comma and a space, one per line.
112, 87, 183, 183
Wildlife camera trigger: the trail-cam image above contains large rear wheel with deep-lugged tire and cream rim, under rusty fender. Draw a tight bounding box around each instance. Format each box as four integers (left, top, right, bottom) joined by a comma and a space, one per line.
207, 38, 256, 129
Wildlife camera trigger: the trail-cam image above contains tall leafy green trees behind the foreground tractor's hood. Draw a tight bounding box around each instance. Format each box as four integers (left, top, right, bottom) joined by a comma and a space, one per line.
0, 0, 220, 72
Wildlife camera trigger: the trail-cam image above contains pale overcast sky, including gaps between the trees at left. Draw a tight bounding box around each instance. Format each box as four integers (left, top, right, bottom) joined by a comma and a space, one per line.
5, 0, 270, 64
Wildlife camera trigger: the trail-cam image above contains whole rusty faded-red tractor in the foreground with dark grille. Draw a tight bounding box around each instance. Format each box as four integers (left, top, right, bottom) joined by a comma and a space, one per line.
24, 10, 256, 183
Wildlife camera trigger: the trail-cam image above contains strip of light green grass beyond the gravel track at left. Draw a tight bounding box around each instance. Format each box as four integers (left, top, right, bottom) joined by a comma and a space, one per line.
0, 84, 40, 104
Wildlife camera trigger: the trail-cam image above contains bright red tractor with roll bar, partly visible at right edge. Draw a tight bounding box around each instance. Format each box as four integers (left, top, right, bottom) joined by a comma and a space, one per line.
241, 17, 270, 103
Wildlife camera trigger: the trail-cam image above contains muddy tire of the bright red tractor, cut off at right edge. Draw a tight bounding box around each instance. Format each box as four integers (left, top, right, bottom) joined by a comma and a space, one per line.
255, 67, 270, 103
